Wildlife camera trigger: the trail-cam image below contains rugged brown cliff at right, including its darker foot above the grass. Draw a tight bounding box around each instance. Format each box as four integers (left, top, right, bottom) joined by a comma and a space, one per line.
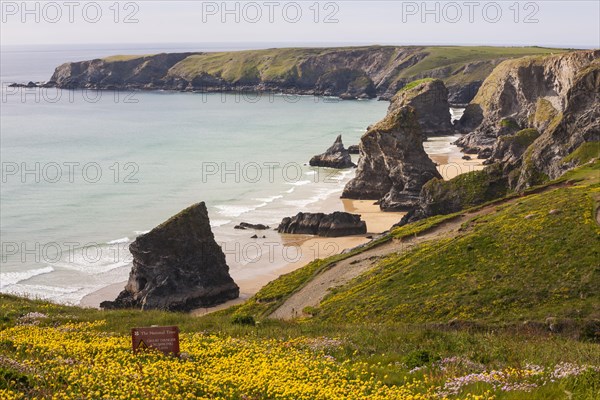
401, 50, 600, 224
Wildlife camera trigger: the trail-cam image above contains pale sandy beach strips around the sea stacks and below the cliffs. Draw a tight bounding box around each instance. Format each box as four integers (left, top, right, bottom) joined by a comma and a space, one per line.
79, 136, 484, 310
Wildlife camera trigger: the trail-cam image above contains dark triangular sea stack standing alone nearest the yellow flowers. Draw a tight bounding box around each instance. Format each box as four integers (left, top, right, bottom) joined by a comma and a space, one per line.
100, 203, 239, 311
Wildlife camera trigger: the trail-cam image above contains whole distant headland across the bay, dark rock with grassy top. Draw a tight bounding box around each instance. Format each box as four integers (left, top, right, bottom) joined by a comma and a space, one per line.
48, 46, 560, 104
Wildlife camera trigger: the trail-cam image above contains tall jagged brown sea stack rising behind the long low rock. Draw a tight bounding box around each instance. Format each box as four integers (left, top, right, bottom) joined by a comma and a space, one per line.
342, 85, 448, 211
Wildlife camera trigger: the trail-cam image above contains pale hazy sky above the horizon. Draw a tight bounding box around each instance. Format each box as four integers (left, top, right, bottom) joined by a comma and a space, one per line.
0, 0, 600, 48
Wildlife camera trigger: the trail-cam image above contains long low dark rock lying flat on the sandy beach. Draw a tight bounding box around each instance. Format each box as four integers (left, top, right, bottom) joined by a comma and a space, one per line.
277, 211, 367, 237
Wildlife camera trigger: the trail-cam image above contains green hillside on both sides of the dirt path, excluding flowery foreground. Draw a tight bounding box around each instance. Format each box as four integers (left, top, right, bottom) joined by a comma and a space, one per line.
238, 162, 600, 325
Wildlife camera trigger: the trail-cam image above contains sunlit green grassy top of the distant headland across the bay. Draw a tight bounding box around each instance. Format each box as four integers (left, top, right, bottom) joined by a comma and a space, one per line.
161, 46, 564, 83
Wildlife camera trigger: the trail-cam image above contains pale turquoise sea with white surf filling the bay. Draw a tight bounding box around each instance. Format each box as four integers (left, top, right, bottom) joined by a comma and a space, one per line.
0, 44, 461, 304
